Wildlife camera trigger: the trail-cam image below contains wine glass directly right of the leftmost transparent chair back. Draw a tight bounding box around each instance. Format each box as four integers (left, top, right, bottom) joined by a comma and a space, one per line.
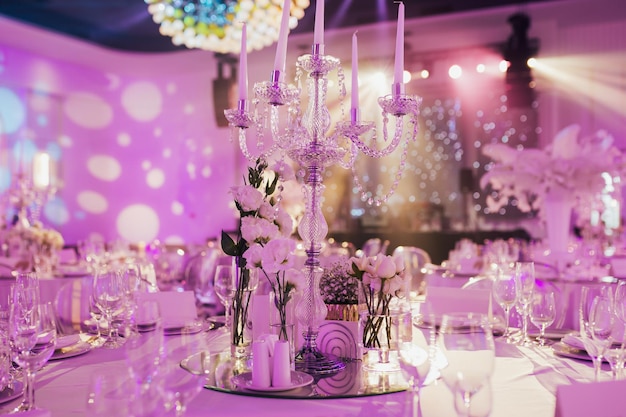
93, 268, 126, 349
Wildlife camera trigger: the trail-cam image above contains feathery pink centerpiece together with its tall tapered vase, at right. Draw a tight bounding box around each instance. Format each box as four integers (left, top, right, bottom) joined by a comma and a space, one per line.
480, 125, 626, 271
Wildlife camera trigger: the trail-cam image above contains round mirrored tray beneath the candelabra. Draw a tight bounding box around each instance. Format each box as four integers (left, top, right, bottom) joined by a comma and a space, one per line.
181, 352, 408, 399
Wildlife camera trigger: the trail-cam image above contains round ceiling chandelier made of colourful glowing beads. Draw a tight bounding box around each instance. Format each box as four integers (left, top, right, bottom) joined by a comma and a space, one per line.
144, 0, 310, 54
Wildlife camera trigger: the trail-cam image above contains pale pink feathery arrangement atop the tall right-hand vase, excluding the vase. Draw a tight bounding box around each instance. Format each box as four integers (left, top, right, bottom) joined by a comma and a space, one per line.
480, 125, 626, 212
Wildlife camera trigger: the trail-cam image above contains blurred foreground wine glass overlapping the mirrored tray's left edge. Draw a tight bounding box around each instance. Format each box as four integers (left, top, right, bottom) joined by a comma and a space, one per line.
159, 332, 208, 417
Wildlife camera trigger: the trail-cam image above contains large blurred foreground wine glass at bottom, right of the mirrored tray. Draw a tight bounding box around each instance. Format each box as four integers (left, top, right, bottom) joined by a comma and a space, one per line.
437, 313, 495, 417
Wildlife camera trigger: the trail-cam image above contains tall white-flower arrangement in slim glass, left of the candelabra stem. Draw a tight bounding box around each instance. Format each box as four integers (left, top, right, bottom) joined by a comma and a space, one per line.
221, 159, 294, 352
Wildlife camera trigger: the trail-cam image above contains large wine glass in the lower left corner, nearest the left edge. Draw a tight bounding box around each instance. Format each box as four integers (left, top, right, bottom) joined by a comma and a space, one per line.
9, 300, 57, 412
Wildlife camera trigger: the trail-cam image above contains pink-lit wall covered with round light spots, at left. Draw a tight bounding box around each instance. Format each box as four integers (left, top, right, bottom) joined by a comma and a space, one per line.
0, 19, 238, 243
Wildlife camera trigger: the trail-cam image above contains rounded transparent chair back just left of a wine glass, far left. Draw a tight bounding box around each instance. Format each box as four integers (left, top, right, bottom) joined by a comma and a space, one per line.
55, 277, 93, 334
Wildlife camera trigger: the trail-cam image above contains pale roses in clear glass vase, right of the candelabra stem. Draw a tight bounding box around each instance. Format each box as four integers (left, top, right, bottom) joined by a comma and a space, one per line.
351, 254, 408, 349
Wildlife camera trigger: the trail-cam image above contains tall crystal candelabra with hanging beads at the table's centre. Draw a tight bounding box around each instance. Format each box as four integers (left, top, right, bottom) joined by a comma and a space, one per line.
224, 2, 421, 375
